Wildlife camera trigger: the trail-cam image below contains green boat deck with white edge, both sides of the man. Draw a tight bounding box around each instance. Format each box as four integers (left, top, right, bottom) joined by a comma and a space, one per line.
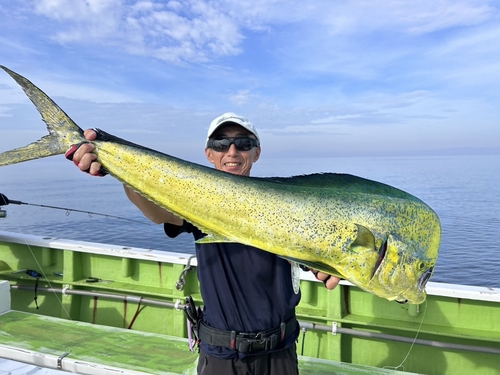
0, 310, 414, 375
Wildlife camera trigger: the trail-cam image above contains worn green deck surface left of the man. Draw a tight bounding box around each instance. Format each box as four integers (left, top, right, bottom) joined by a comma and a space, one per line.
0, 311, 197, 374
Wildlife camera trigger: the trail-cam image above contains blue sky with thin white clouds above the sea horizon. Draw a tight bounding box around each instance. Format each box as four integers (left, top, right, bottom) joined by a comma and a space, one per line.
0, 0, 500, 161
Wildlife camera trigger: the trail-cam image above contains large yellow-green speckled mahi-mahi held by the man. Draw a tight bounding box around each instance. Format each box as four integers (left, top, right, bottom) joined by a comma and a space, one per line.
0, 66, 441, 304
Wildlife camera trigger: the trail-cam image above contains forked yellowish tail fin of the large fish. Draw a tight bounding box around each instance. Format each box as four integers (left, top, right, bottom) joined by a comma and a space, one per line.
0, 65, 85, 166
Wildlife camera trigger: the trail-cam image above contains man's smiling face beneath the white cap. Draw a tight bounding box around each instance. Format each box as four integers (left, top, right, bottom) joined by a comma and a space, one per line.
205, 125, 260, 176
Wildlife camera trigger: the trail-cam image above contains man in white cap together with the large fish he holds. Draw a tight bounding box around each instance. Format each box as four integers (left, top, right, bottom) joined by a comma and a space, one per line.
0, 65, 441, 375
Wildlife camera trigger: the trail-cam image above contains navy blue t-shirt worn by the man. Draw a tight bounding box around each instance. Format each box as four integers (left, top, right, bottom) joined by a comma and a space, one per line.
165, 221, 300, 358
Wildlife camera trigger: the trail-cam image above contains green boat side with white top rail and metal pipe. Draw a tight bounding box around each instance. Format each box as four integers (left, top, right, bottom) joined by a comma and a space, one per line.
0, 231, 500, 375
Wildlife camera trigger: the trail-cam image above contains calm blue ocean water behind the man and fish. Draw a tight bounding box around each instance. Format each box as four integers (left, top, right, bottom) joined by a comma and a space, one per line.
0, 155, 500, 288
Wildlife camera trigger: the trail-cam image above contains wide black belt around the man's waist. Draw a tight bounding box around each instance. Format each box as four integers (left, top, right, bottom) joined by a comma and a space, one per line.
198, 317, 297, 352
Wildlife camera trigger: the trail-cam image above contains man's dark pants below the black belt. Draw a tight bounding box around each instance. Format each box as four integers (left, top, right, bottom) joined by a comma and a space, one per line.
198, 344, 299, 375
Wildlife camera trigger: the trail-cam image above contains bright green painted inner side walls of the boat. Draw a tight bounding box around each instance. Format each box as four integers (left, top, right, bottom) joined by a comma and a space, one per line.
0, 237, 500, 375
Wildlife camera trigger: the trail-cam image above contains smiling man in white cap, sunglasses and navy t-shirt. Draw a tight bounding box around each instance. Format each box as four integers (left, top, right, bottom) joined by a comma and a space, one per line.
67, 112, 339, 375
